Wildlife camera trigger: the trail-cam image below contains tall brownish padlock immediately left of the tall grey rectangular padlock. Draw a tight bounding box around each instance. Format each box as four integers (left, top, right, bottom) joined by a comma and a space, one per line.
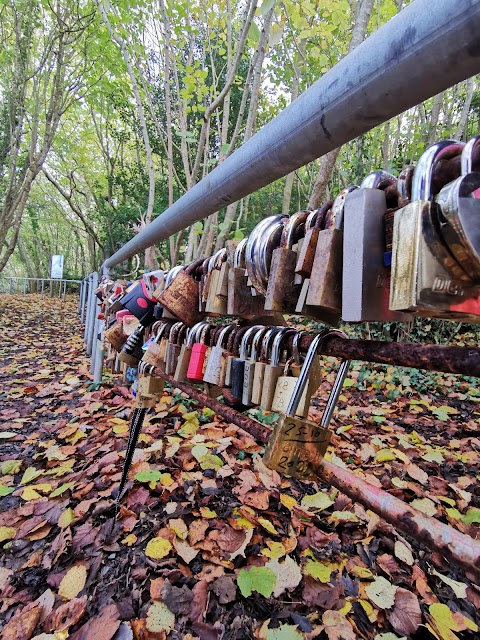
306, 187, 356, 326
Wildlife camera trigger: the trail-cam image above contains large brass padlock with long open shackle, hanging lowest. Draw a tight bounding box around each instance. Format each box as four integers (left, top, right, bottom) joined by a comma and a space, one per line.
263, 335, 350, 480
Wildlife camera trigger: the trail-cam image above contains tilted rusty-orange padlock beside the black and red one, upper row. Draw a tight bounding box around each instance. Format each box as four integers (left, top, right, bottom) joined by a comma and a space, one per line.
158, 258, 203, 327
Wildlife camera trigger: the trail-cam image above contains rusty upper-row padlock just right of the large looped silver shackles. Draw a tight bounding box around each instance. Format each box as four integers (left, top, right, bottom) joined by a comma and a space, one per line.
265, 211, 310, 313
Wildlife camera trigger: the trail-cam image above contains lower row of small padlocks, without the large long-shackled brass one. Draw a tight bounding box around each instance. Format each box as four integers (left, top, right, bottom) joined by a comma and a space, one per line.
108, 321, 346, 417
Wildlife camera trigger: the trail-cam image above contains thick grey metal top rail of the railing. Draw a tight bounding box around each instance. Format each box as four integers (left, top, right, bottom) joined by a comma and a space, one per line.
104, 0, 480, 269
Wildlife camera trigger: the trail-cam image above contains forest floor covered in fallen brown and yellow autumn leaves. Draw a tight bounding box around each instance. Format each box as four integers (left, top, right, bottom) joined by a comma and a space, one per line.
0, 295, 480, 640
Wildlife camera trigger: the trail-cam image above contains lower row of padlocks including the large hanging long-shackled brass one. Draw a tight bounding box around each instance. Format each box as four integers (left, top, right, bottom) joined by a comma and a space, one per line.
129, 321, 350, 479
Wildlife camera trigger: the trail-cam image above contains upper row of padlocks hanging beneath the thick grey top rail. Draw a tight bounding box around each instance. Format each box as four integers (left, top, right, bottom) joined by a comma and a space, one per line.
99, 136, 480, 327
